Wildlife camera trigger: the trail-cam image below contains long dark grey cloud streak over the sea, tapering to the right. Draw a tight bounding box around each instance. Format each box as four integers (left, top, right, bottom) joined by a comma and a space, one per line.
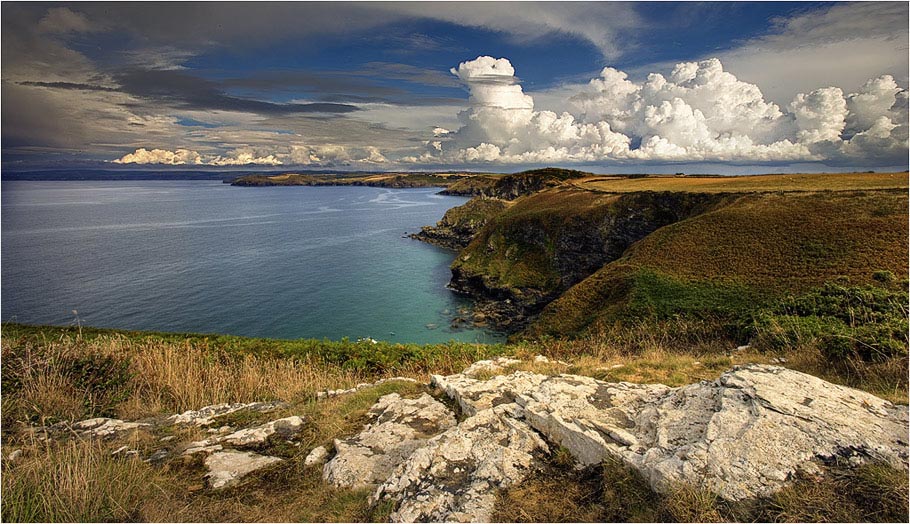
114, 69, 357, 115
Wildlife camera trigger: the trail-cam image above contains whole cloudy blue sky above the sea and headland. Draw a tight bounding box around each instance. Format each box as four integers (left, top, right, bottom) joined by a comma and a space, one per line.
0, 2, 910, 173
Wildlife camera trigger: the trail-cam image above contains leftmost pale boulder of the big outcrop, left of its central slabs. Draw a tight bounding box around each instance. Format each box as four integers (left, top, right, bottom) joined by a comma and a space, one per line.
323, 393, 455, 487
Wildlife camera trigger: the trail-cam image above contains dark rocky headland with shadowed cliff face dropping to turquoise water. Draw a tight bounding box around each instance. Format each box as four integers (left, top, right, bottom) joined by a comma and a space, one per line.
450, 189, 736, 331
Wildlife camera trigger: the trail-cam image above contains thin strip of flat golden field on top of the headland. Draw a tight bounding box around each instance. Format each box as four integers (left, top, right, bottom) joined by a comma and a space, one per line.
570, 172, 910, 193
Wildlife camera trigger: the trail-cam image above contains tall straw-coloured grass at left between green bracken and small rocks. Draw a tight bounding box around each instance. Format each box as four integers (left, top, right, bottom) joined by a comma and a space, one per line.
3, 335, 407, 425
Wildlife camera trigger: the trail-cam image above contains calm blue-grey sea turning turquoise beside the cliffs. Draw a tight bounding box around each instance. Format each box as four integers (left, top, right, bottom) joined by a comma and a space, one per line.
0, 181, 501, 343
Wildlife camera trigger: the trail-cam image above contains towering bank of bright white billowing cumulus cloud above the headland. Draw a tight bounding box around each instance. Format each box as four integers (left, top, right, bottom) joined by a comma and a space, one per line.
422, 56, 907, 163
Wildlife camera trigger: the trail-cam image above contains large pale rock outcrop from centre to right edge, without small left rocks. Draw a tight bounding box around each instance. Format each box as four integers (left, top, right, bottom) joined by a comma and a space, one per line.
325, 359, 908, 521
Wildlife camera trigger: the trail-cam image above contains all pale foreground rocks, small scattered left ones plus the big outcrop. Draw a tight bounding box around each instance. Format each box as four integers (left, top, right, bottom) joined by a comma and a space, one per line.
32, 357, 908, 522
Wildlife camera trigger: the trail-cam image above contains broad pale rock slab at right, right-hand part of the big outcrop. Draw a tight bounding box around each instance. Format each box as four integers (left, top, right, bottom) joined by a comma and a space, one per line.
516, 365, 908, 500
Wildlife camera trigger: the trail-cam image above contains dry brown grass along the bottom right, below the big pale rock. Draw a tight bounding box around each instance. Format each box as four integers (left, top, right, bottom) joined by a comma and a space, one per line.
493, 453, 908, 522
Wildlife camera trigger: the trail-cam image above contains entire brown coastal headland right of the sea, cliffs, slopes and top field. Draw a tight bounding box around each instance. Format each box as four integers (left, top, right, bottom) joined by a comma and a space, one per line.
416, 170, 908, 337
